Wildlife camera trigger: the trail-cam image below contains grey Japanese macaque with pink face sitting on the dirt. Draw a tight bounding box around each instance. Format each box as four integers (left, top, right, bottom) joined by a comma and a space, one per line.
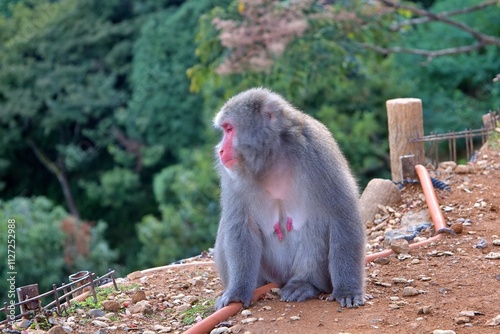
214, 88, 365, 309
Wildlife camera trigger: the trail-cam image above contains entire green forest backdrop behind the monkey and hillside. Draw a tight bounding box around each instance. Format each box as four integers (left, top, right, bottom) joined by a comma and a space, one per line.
0, 0, 500, 297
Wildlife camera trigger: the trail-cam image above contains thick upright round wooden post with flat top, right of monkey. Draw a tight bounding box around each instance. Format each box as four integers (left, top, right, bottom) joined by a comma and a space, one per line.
386, 98, 425, 182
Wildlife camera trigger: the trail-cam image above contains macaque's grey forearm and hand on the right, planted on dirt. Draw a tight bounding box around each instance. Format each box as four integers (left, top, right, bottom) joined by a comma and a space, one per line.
328, 224, 365, 307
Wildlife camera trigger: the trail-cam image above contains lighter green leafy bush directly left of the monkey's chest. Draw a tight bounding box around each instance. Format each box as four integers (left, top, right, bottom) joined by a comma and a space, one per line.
137, 147, 219, 266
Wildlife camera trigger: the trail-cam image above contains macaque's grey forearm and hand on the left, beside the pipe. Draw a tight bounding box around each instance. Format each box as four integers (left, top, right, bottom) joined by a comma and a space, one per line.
215, 214, 262, 309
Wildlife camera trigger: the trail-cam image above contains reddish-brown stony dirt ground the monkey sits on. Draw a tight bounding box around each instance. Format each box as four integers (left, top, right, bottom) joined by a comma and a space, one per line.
4, 136, 500, 334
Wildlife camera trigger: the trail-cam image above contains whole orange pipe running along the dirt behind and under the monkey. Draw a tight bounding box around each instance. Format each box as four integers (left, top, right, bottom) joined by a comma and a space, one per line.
184, 165, 446, 334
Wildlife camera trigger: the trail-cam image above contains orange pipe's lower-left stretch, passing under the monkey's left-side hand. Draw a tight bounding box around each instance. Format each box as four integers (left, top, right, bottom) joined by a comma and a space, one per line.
184, 283, 278, 334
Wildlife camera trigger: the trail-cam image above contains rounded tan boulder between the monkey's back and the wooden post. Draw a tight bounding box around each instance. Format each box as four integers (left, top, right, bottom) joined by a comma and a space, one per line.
360, 179, 401, 223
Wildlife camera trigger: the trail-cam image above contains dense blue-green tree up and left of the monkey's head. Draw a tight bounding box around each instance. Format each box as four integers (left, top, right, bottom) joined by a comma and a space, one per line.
126, 1, 216, 159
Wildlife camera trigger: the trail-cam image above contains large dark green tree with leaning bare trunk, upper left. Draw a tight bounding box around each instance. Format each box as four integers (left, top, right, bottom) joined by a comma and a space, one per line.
0, 0, 157, 268
